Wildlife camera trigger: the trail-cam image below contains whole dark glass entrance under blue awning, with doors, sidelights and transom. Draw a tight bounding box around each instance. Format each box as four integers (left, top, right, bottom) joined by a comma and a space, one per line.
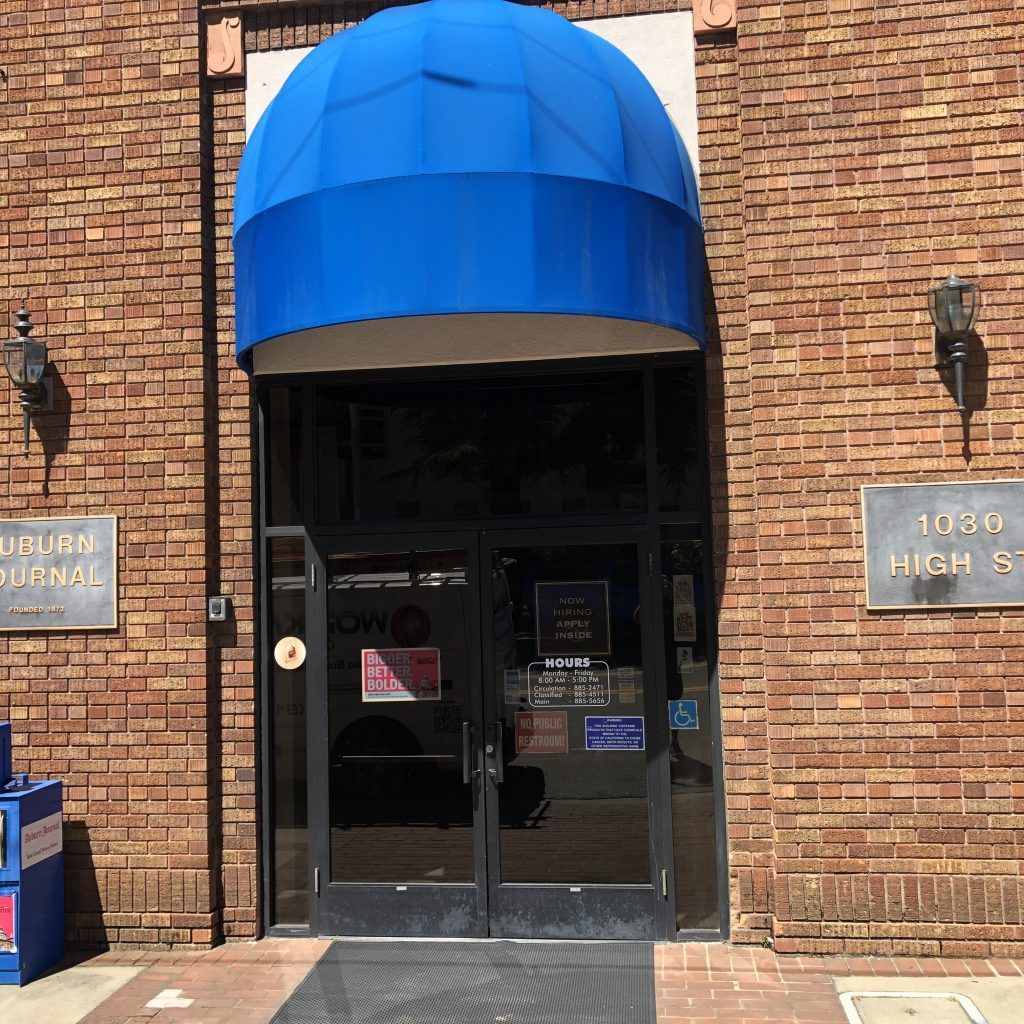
261, 365, 725, 939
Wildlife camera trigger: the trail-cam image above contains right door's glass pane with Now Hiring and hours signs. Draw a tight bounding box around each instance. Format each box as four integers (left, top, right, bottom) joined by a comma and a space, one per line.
492, 544, 651, 885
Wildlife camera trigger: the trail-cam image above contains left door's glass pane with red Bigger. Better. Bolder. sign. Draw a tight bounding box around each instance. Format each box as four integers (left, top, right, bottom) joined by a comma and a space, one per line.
327, 550, 475, 883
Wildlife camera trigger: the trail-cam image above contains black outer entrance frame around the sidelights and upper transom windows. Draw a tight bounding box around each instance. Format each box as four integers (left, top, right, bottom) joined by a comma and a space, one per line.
260, 355, 730, 941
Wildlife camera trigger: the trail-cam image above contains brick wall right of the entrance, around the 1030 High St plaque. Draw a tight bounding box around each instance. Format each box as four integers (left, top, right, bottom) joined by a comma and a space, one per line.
698, 0, 1024, 955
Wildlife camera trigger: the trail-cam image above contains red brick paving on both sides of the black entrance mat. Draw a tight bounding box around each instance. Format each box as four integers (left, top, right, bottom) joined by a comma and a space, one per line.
54, 939, 1024, 1024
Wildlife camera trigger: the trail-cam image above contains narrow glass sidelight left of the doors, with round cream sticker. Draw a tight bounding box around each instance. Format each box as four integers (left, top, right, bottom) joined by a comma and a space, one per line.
269, 538, 309, 925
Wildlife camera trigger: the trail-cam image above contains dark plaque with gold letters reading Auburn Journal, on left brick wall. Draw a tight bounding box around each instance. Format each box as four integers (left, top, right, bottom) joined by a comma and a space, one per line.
0, 515, 118, 632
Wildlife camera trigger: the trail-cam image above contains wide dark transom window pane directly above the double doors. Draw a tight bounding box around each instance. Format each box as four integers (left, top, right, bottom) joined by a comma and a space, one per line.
316, 372, 647, 522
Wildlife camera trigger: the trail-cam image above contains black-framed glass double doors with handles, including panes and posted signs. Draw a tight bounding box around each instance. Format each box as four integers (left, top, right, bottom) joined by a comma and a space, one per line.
310, 528, 667, 939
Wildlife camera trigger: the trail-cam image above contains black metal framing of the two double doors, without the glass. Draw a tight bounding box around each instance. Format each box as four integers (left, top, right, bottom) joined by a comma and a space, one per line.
306, 525, 671, 940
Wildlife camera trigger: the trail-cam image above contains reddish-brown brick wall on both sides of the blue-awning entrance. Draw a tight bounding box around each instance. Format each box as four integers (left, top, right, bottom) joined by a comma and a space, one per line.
0, 0, 1024, 954
